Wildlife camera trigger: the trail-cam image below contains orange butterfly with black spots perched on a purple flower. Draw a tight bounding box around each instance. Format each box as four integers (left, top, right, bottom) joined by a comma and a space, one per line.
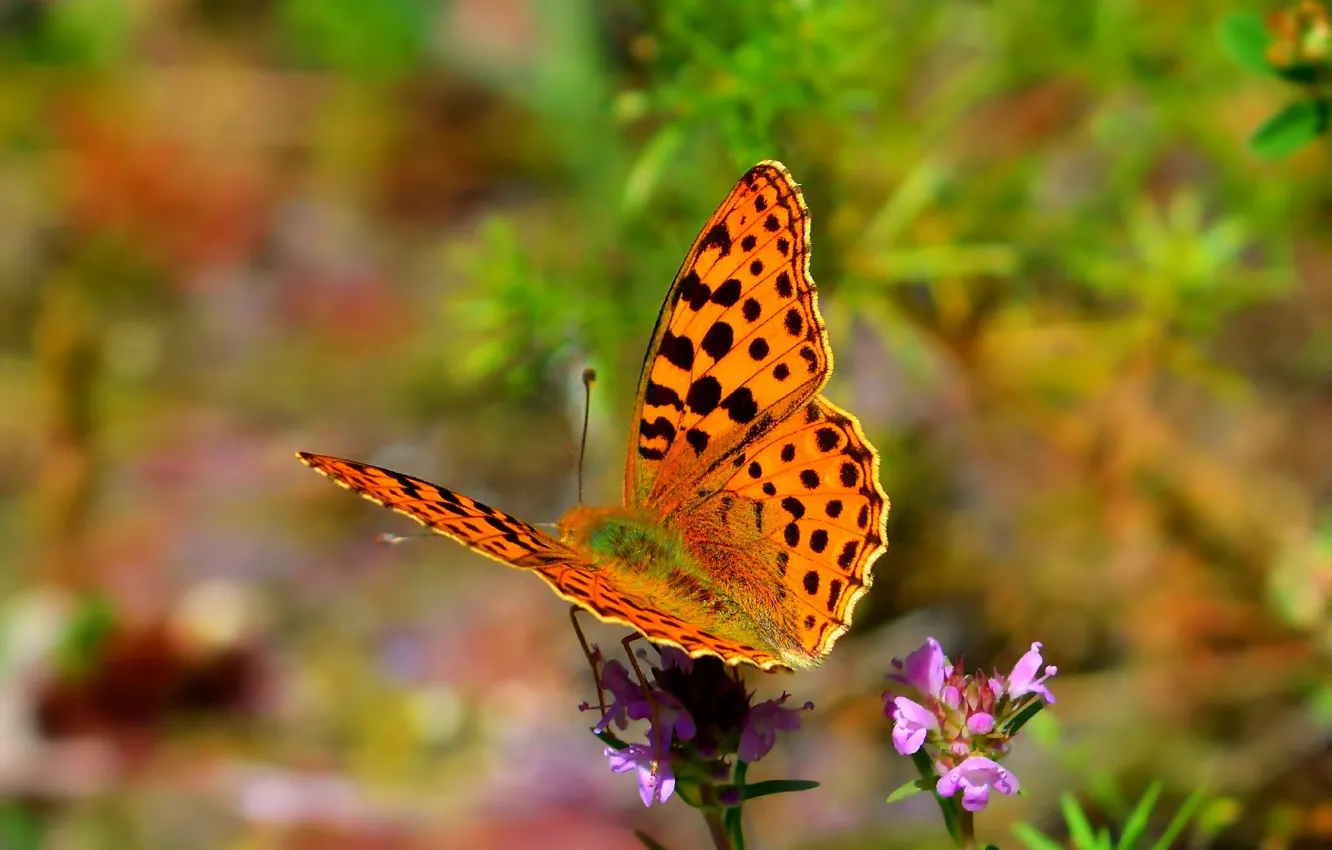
297, 160, 888, 670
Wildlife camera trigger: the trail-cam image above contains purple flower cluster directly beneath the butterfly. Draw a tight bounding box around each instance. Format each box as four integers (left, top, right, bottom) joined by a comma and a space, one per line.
579, 647, 814, 806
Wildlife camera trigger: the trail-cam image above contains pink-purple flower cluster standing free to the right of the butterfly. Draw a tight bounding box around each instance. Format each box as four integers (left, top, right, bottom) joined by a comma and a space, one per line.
883, 638, 1056, 811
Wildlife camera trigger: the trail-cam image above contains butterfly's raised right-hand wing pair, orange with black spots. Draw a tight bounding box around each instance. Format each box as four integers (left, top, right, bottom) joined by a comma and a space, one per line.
625, 161, 888, 666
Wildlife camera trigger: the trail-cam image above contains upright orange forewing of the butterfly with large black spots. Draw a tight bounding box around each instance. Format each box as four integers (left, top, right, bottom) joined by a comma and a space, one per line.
626, 163, 831, 506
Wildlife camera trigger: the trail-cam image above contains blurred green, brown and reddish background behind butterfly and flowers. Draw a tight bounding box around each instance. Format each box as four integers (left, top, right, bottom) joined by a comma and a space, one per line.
0, 0, 1332, 850
